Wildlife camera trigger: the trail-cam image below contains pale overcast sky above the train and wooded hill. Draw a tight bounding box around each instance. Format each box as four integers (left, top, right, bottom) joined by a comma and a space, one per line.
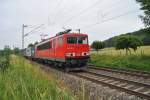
0, 0, 144, 49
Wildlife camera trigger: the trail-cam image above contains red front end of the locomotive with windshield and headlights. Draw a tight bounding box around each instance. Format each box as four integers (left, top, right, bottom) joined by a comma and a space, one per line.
65, 33, 90, 66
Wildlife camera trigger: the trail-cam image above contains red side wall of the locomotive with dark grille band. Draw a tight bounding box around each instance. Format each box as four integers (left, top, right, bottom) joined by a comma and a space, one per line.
35, 36, 65, 62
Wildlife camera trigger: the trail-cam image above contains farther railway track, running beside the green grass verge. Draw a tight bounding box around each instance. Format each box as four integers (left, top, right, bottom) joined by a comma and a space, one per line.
88, 64, 150, 79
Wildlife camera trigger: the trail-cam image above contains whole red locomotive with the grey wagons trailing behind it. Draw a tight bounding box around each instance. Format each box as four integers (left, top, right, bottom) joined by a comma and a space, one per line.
23, 30, 90, 72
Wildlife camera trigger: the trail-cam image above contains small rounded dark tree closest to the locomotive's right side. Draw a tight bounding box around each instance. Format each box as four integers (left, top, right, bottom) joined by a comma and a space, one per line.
91, 41, 105, 53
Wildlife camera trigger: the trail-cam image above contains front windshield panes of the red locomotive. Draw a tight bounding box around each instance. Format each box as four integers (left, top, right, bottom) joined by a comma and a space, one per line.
67, 37, 88, 44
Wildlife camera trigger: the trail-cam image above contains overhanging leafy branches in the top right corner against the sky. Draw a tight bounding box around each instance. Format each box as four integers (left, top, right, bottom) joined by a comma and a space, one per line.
136, 0, 150, 27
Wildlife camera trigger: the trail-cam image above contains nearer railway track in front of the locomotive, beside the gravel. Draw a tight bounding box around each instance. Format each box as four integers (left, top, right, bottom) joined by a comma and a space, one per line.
71, 70, 150, 100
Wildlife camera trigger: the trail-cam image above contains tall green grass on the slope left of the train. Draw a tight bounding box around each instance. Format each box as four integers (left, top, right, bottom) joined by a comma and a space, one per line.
0, 55, 73, 100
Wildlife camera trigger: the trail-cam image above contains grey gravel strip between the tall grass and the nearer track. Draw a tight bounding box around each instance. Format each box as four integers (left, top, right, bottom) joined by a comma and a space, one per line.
38, 66, 146, 100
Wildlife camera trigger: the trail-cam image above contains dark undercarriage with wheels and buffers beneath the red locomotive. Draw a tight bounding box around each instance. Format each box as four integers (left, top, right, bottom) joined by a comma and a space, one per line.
33, 57, 89, 72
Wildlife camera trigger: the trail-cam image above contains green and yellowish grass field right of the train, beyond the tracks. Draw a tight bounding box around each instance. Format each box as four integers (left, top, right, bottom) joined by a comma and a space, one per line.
90, 46, 150, 72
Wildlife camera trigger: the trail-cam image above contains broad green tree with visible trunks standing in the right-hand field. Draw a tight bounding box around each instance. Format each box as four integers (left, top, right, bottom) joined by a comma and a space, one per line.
116, 36, 142, 54
